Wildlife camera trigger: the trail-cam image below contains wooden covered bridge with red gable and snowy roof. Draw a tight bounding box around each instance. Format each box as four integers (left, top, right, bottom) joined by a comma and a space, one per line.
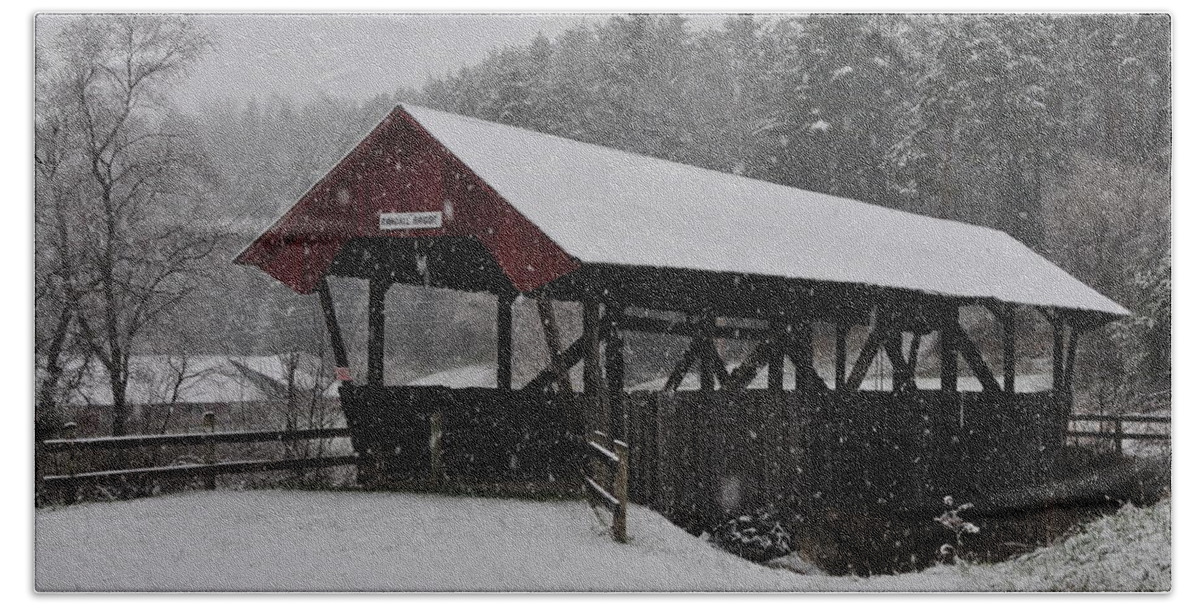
236, 106, 1127, 537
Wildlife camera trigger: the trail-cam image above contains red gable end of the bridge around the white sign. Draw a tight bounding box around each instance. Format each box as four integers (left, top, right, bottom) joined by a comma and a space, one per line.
234, 107, 580, 294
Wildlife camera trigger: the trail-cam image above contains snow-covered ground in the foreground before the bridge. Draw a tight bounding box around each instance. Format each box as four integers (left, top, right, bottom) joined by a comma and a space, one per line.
35, 490, 1170, 591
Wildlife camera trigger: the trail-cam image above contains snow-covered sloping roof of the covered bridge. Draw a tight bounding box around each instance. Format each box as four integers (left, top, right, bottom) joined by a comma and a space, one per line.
401, 106, 1128, 315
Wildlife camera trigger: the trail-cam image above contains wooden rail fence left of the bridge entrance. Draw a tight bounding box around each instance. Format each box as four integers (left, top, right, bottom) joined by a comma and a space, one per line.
41, 422, 358, 504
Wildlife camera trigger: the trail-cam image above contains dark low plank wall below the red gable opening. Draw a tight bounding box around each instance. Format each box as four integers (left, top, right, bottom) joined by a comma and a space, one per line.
340, 386, 586, 494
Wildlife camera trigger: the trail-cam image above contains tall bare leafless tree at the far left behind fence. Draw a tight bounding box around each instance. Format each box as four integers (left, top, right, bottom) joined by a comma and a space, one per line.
37, 16, 215, 435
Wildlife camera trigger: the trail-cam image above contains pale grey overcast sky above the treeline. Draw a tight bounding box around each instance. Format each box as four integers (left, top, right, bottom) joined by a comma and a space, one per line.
37, 13, 724, 112
